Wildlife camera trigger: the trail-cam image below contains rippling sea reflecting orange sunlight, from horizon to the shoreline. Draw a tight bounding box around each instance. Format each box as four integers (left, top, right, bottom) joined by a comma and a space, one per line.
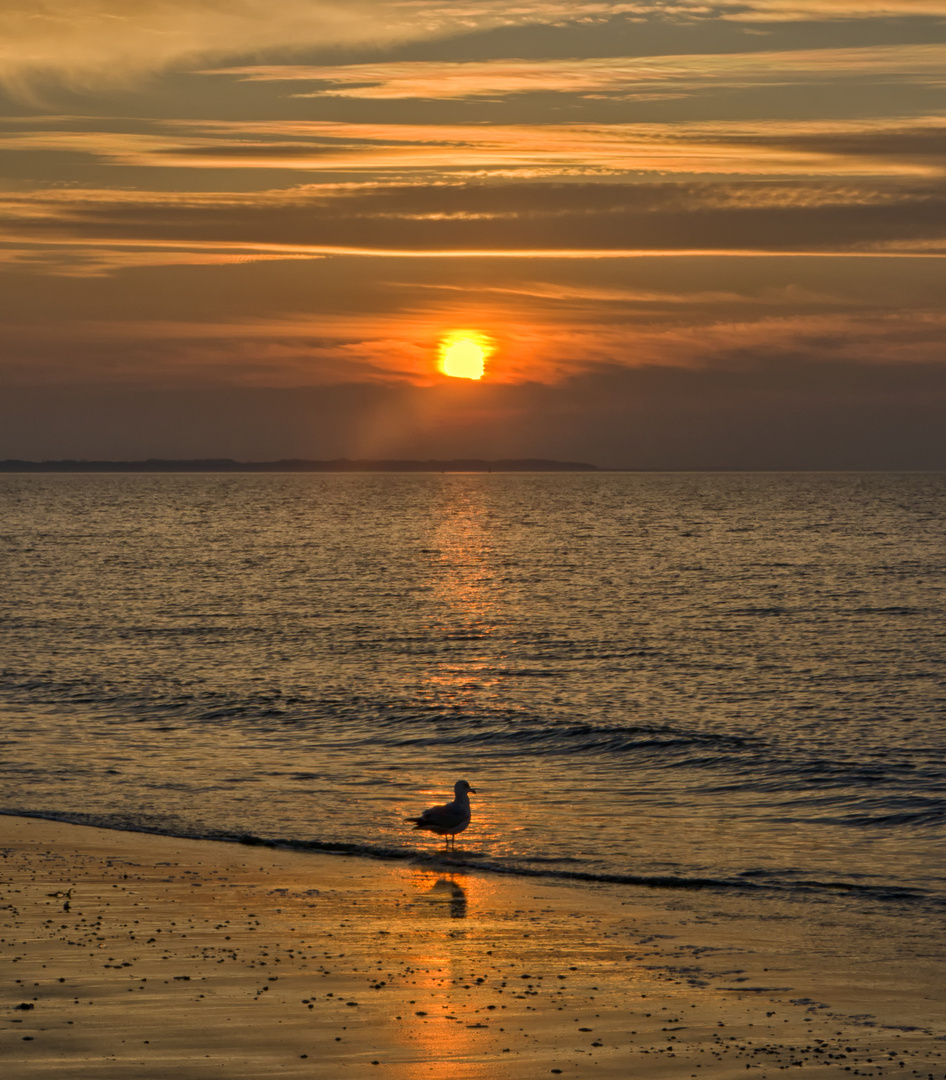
0, 473, 946, 916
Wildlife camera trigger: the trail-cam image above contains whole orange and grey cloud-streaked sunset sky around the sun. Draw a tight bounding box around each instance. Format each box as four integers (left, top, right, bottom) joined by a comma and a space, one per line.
0, 0, 946, 469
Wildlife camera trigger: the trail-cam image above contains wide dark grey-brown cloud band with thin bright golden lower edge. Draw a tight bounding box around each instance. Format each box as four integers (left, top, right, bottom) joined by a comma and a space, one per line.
0, 179, 946, 273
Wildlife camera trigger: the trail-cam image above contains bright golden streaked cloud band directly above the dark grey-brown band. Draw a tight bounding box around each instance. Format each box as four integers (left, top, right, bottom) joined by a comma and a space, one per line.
7, 116, 946, 178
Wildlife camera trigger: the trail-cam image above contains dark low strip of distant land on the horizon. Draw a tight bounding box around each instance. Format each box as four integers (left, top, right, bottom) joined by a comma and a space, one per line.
0, 458, 597, 473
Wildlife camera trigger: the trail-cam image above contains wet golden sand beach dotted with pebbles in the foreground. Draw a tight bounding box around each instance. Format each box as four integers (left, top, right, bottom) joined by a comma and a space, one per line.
0, 816, 946, 1080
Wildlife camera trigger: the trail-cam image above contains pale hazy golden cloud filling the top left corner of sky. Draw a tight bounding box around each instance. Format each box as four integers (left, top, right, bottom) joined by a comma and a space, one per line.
0, 0, 725, 95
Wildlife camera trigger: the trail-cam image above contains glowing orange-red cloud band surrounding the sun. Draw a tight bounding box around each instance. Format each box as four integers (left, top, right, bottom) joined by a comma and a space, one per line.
0, 303, 946, 389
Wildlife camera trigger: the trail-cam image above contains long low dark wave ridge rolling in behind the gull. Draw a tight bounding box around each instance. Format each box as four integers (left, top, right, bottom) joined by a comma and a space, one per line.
0, 673, 946, 816
